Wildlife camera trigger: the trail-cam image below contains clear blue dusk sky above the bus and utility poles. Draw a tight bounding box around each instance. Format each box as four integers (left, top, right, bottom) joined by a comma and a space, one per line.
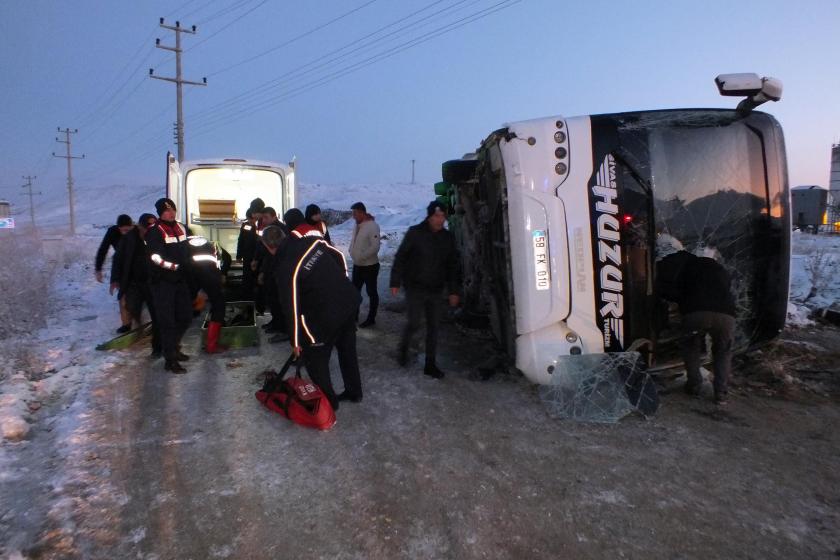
0, 0, 840, 210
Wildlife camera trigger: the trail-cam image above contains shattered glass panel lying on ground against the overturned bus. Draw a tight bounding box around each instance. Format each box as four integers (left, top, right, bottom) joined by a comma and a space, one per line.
539, 352, 659, 424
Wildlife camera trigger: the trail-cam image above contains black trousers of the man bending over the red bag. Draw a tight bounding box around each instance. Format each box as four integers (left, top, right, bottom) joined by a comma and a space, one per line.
303, 317, 362, 406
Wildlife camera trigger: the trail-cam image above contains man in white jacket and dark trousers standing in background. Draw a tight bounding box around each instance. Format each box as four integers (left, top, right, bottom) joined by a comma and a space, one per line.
350, 202, 379, 329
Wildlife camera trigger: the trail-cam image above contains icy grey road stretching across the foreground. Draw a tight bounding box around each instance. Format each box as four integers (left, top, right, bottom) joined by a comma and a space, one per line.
0, 255, 840, 559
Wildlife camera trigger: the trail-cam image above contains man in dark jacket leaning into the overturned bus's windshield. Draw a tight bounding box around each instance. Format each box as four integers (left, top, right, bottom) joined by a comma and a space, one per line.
656, 251, 735, 404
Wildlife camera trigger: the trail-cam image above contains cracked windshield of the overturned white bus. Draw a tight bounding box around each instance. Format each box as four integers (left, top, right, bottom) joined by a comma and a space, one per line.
601, 110, 787, 358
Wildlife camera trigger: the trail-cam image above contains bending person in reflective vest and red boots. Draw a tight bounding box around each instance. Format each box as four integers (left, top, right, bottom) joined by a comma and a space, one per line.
187, 235, 227, 354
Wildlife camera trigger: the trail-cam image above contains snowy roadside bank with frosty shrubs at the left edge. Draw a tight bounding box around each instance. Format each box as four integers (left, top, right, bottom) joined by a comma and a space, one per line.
0, 233, 119, 442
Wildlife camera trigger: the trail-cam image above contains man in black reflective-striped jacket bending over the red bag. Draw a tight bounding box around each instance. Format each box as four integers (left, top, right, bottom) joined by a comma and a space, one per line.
262, 220, 362, 409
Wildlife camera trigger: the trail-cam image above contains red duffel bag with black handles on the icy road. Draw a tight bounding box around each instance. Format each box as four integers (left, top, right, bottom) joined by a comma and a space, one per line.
256, 355, 335, 430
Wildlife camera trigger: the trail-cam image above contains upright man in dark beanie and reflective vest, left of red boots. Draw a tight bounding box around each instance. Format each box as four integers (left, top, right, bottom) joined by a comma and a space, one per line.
146, 198, 192, 373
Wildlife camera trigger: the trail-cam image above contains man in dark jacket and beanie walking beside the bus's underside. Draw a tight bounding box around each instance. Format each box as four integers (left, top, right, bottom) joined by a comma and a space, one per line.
391, 200, 461, 379
